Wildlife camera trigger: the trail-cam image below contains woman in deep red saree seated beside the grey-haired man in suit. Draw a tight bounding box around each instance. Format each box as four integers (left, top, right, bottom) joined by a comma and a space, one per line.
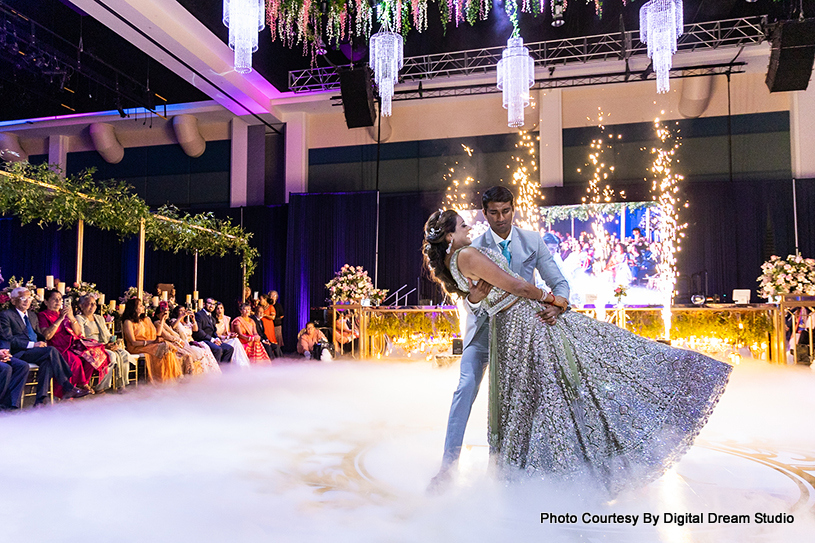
37, 290, 110, 390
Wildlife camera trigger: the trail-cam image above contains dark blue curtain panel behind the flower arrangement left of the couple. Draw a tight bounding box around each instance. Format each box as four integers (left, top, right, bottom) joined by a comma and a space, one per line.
283, 192, 380, 345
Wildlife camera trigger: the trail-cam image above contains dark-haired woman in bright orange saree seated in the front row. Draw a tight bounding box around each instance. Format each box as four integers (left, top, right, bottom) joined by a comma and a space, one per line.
122, 298, 182, 383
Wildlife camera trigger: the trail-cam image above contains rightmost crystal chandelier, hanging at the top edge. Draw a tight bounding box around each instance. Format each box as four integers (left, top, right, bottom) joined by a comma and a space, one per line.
640, 0, 683, 93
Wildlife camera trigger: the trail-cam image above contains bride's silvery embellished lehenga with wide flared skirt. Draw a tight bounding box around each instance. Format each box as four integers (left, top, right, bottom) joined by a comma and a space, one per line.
450, 249, 731, 495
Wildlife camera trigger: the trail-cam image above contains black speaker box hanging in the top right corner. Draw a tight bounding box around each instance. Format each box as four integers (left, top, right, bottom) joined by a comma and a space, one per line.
766, 19, 815, 92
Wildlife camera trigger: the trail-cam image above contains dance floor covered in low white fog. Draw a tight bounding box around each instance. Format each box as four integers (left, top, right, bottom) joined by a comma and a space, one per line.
0, 354, 815, 543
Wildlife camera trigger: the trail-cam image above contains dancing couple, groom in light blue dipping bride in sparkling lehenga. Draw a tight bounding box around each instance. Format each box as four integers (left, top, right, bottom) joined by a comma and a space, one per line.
423, 186, 731, 496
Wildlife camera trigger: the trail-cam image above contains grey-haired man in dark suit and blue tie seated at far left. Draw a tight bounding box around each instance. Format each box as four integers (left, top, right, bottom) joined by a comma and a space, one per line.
0, 287, 90, 405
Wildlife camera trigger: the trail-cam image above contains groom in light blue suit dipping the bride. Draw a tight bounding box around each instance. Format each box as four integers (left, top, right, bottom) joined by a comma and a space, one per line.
428, 186, 569, 491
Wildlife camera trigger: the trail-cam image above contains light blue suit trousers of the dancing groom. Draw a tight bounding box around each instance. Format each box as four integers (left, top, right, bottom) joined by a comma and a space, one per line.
442, 322, 490, 467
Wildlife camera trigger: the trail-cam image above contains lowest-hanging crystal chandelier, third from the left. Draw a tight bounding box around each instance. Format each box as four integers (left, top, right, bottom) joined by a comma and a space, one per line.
498, 37, 535, 127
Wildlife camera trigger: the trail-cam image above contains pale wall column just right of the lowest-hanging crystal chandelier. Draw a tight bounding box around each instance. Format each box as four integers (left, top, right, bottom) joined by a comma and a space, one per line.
538, 89, 563, 187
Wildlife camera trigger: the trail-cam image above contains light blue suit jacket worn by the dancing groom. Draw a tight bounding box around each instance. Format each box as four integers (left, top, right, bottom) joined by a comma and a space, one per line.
464, 226, 569, 350
